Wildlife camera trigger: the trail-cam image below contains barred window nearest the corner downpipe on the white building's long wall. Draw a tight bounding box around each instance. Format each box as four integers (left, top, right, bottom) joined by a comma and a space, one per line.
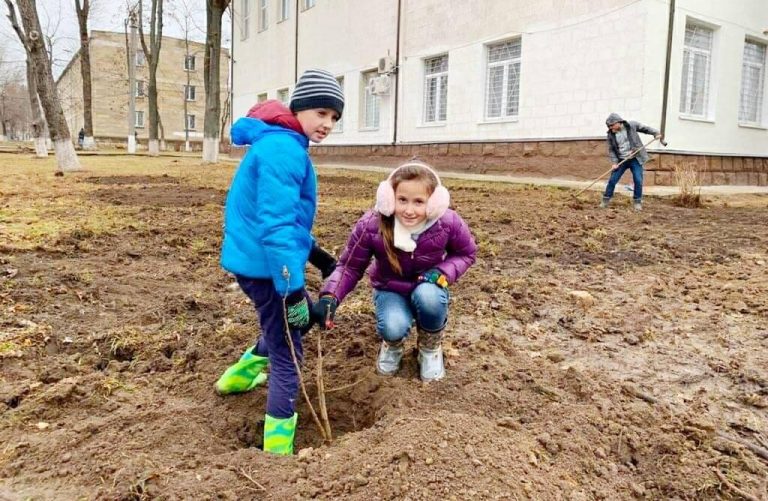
485, 38, 522, 119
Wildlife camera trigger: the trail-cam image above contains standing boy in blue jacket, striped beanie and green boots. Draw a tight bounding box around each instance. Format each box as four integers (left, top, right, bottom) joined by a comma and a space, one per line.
216, 70, 344, 455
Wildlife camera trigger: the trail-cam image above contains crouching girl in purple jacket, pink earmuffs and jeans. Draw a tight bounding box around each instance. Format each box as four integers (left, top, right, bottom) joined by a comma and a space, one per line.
313, 161, 477, 381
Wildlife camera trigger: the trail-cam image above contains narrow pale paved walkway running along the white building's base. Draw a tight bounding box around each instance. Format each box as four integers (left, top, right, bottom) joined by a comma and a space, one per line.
317, 163, 768, 197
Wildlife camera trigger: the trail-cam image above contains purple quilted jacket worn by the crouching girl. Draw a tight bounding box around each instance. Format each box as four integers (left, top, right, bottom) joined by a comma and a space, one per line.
320, 209, 477, 302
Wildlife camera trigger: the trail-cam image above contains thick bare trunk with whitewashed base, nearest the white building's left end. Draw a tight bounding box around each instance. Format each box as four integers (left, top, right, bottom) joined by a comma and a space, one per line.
203, 0, 230, 163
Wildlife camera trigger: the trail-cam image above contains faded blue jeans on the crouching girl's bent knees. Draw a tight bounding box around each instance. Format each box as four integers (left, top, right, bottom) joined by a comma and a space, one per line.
373, 283, 450, 343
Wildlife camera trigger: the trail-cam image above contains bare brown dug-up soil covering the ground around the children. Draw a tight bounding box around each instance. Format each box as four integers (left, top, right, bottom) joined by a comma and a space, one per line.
0, 161, 768, 500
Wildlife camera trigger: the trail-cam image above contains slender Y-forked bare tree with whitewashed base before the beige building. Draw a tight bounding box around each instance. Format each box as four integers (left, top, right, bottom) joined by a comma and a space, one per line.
140, 0, 163, 156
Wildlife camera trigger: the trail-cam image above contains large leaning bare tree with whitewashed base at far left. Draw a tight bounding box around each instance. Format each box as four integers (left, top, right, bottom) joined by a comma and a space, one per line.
5, 0, 80, 170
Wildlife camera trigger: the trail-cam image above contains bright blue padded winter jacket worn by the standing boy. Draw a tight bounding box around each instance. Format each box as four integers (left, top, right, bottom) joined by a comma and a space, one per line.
221, 118, 317, 295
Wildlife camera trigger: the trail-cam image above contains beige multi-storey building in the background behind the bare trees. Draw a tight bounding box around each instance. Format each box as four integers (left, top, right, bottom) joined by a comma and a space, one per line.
56, 30, 230, 150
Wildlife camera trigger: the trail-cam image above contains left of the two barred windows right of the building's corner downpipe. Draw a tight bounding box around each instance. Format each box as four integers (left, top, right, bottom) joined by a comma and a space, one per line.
680, 22, 715, 117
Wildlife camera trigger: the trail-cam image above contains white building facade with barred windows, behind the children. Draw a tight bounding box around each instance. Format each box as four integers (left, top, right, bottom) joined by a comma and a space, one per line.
233, 0, 768, 184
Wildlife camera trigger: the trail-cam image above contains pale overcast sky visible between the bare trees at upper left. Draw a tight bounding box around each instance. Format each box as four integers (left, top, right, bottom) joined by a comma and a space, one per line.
0, 0, 230, 78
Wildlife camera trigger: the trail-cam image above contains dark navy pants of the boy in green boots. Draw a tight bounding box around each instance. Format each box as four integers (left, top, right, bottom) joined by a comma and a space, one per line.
237, 276, 309, 419
